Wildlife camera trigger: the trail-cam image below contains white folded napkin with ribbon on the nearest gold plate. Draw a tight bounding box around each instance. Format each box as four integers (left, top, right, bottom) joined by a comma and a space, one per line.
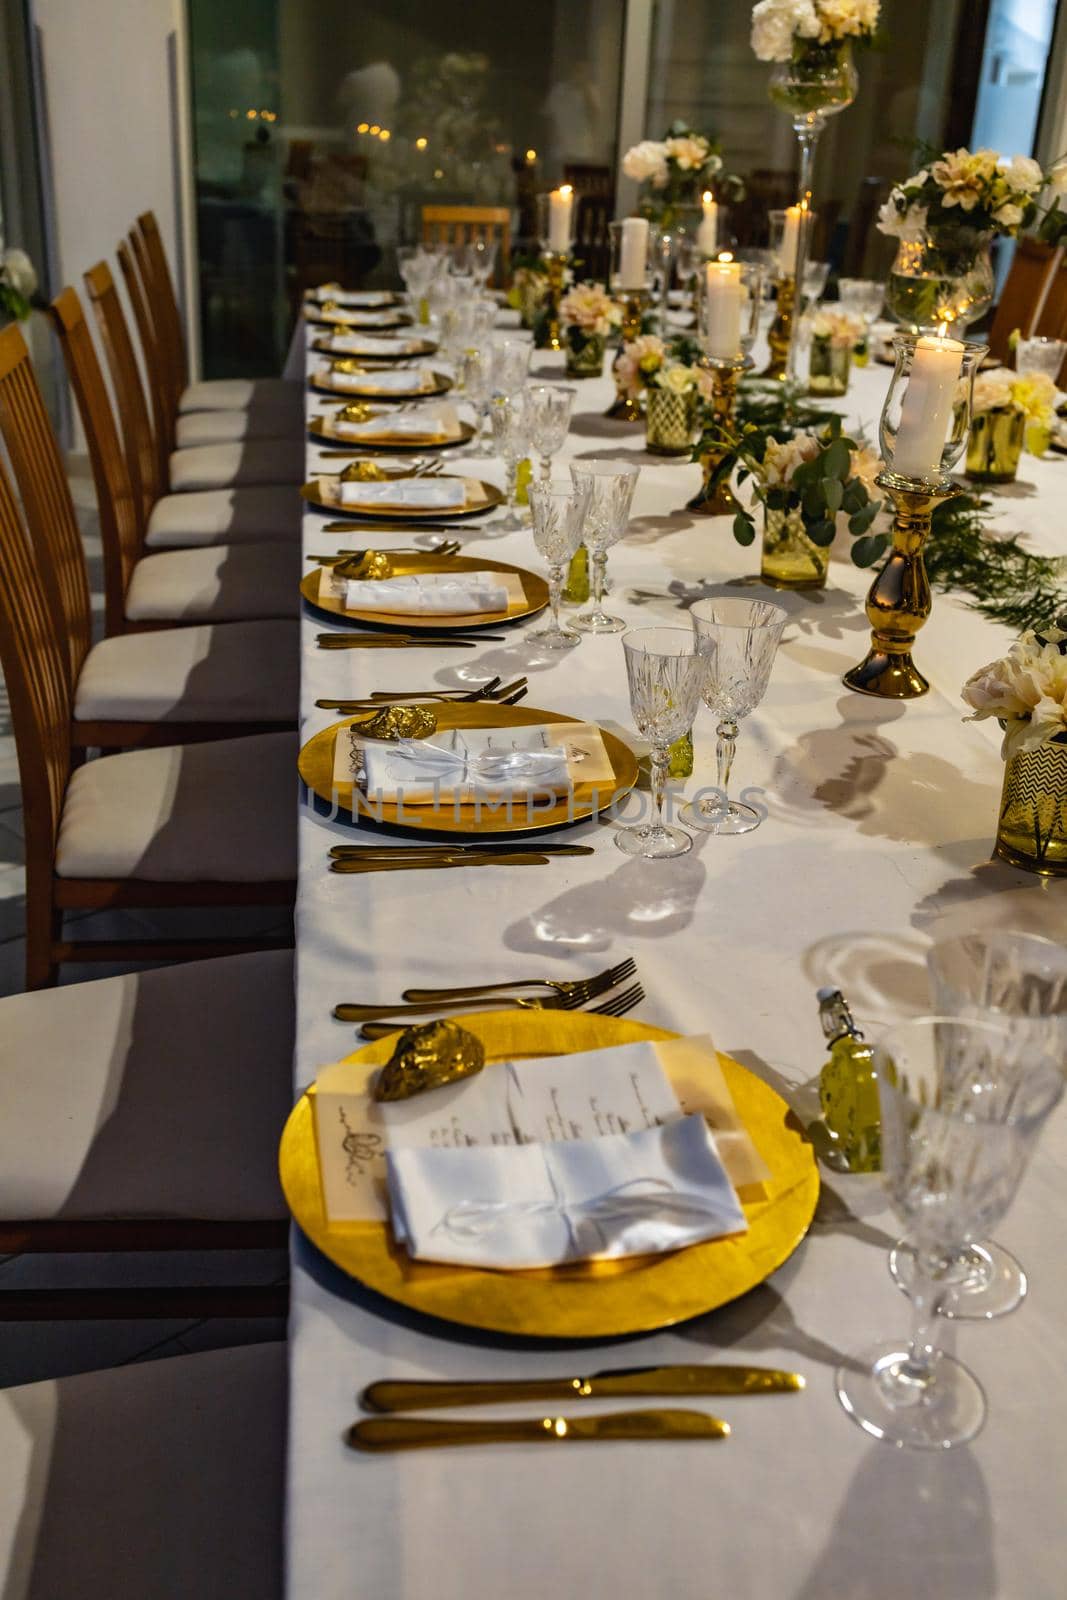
386, 1114, 747, 1269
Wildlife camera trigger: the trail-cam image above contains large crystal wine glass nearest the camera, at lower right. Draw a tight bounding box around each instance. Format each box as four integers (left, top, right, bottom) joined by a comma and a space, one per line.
837, 1016, 1064, 1450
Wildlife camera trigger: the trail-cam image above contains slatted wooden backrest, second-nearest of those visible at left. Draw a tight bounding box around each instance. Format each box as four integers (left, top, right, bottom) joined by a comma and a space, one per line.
0, 323, 93, 691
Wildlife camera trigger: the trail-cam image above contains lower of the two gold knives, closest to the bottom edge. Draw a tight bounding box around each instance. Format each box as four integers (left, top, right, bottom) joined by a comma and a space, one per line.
346, 1411, 729, 1450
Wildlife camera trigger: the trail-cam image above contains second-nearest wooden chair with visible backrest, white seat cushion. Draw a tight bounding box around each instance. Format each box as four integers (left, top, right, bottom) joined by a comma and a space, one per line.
0, 325, 298, 749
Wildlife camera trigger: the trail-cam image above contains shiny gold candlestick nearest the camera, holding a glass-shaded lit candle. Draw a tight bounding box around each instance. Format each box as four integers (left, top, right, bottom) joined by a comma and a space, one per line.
843, 472, 963, 699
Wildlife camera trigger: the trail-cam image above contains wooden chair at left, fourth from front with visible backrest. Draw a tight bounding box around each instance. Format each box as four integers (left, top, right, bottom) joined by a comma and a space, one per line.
85, 245, 302, 549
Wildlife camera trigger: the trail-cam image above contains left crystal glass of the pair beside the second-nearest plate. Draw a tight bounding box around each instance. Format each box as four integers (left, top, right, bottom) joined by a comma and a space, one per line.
614, 627, 705, 859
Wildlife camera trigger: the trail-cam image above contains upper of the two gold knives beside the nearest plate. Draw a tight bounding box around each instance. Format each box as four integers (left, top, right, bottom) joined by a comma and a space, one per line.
362, 1365, 805, 1411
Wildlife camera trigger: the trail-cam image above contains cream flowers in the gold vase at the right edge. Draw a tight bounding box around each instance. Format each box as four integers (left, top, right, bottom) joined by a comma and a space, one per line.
963, 619, 1067, 760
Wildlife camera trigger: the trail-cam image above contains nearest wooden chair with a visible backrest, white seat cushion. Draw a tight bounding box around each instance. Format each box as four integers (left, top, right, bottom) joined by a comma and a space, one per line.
0, 438, 298, 989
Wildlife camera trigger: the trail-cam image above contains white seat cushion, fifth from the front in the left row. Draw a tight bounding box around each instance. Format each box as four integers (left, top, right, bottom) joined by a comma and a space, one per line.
126, 542, 301, 622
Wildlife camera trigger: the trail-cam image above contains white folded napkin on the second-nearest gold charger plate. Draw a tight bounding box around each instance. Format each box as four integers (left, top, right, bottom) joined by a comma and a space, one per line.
362, 726, 573, 805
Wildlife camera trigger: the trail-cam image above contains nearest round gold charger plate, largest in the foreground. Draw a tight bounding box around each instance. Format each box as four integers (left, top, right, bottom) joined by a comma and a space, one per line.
278, 1011, 819, 1339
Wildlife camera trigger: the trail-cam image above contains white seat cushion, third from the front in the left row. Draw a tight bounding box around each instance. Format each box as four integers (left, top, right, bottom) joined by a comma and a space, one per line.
56, 732, 299, 883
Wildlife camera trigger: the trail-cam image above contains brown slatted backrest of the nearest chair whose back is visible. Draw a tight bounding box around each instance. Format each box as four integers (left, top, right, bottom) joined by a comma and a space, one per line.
0, 400, 72, 876
